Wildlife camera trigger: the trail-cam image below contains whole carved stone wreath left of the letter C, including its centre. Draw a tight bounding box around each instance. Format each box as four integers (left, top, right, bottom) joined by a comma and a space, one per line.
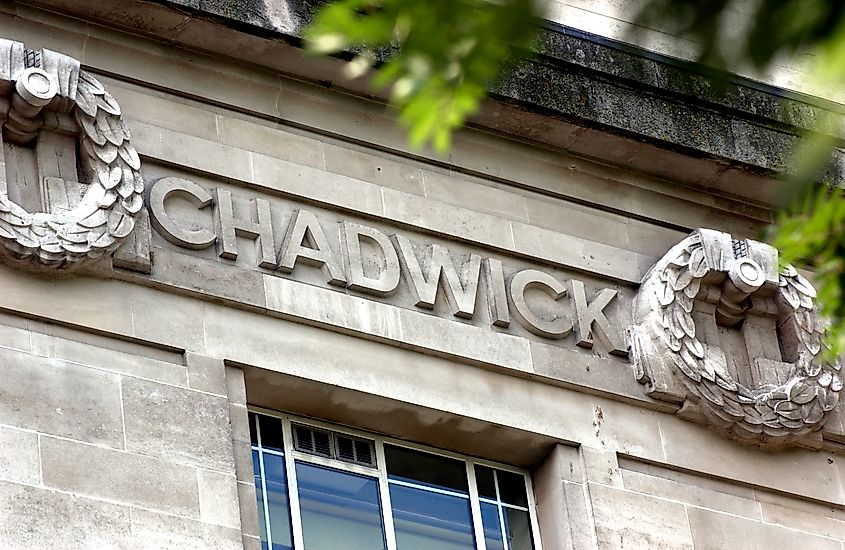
0, 39, 144, 272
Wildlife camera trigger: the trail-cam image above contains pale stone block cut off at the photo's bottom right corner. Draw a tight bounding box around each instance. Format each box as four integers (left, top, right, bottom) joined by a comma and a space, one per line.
688, 508, 842, 550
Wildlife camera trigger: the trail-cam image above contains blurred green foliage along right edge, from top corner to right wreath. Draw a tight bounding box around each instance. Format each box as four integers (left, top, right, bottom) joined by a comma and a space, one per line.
635, 0, 845, 358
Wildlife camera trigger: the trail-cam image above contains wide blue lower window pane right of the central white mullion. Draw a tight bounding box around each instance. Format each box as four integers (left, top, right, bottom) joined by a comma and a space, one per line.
390, 484, 475, 550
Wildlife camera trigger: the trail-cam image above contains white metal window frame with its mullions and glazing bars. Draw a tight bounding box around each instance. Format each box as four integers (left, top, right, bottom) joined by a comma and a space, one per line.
247, 405, 543, 550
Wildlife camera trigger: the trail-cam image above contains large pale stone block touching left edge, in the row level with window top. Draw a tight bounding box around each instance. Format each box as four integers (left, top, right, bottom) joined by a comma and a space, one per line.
0, 349, 123, 448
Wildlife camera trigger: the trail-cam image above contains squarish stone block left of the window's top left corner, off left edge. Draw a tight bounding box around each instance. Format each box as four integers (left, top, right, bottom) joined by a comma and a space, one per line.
122, 378, 234, 473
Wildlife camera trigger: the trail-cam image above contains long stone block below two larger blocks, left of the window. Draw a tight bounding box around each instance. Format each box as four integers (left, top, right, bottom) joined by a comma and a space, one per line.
41, 437, 200, 517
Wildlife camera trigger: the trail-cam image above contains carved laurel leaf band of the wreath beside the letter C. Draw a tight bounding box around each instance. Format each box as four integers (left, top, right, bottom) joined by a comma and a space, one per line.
0, 70, 144, 269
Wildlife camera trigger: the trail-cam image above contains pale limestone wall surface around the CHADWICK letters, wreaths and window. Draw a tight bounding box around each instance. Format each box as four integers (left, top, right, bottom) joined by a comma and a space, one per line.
0, 6, 845, 550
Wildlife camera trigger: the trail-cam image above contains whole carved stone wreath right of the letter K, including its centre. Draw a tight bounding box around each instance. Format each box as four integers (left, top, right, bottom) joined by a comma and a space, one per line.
628, 229, 843, 447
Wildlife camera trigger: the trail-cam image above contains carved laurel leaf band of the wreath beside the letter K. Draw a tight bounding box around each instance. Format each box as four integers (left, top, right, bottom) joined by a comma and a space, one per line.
644, 232, 843, 437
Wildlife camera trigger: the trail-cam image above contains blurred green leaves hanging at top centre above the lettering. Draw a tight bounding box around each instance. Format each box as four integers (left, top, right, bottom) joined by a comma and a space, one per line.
305, 0, 539, 153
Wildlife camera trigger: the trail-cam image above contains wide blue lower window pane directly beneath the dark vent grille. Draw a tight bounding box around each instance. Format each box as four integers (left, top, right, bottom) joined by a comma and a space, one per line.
296, 462, 385, 550
